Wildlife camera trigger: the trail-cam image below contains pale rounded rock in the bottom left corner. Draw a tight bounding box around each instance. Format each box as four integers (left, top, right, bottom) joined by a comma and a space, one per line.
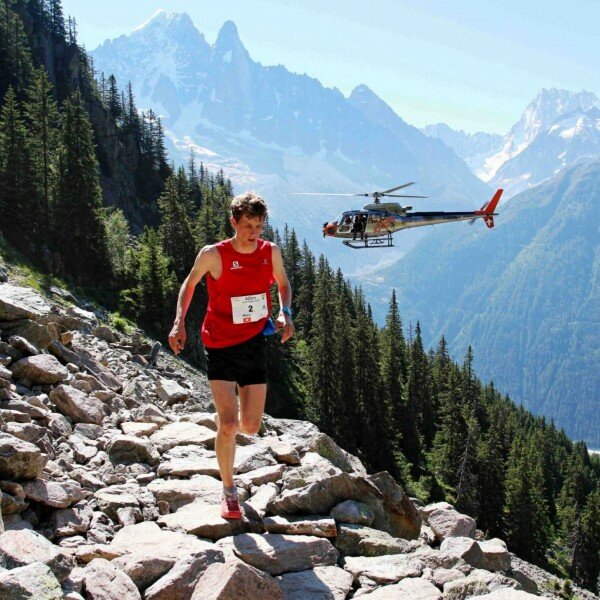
0, 562, 63, 600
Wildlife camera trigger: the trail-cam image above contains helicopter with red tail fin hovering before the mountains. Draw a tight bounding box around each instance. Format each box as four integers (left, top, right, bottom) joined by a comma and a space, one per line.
294, 181, 504, 250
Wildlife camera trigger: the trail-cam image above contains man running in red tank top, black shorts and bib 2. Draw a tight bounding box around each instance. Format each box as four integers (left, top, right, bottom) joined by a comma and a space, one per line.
169, 192, 294, 519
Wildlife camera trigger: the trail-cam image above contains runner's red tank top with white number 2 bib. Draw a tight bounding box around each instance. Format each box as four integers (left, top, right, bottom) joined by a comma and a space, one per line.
202, 240, 275, 348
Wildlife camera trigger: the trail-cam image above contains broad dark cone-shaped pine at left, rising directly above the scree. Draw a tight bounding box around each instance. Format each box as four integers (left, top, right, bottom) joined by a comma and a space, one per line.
52, 92, 111, 284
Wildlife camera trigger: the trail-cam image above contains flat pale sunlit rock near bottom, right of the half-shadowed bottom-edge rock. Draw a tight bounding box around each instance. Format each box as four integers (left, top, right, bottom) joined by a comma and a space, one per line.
343, 554, 423, 585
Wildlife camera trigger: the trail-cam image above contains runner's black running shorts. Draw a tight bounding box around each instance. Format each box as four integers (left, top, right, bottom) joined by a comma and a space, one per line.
204, 333, 267, 387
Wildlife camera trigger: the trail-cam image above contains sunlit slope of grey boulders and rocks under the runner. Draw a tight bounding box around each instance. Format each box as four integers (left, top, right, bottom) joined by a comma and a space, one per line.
0, 283, 595, 600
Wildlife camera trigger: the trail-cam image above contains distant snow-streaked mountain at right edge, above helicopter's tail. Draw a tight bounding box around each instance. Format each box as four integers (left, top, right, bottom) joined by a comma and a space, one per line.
422, 88, 600, 198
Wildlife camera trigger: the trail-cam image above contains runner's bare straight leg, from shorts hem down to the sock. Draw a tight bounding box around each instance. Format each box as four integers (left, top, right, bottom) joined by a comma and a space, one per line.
209, 379, 240, 488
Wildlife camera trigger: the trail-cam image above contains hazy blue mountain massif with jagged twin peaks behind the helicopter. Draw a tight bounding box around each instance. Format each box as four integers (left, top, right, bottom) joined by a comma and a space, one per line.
92, 11, 490, 272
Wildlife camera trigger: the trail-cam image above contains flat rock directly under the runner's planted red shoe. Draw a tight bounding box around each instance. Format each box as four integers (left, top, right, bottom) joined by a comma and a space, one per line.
157, 501, 265, 540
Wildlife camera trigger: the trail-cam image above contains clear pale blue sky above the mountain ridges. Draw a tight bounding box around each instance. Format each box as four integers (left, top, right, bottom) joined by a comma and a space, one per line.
63, 0, 600, 133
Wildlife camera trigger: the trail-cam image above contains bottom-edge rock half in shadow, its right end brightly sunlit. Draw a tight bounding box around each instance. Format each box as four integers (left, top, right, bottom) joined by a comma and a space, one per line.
275, 567, 352, 600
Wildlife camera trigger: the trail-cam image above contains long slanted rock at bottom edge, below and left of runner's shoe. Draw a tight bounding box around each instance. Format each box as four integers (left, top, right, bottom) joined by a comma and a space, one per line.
144, 548, 225, 600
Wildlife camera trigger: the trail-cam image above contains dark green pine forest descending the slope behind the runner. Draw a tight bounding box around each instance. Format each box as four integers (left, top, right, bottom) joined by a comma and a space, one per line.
0, 0, 600, 591
